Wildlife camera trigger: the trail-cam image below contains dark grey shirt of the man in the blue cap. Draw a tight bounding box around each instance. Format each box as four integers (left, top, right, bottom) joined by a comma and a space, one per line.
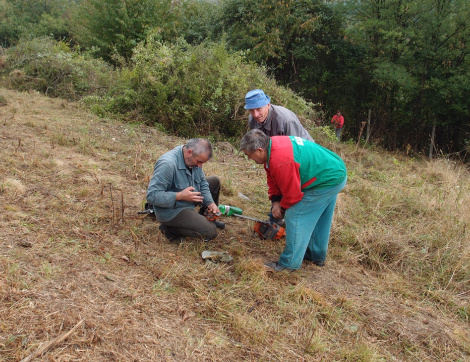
248, 104, 313, 141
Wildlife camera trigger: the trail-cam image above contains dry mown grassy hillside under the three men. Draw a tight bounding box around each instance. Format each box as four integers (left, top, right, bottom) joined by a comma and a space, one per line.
0, 89, 470, 361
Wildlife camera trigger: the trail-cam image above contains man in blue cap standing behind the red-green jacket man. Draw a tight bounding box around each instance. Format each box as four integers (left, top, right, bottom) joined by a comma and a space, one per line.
245, 89, 313, 141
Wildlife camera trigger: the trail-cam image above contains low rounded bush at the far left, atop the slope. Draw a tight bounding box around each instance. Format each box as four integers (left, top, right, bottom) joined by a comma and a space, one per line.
3, 37, 114, 100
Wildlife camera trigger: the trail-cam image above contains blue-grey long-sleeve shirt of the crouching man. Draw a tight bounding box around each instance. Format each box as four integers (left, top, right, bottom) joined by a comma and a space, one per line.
147, 146, 214, 222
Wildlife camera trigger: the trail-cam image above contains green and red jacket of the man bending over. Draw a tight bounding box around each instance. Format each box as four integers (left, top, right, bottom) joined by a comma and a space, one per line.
264, 136, 346, 209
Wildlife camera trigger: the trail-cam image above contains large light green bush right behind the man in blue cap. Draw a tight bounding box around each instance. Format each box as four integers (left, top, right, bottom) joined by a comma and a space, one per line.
105, 34, 320, 139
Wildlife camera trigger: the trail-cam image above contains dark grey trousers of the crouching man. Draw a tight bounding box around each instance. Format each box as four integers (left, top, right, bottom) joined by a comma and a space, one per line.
162, 176, 220, 240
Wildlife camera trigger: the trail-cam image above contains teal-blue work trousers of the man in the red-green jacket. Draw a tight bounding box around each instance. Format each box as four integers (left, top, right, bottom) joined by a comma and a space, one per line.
279, 179, 346, 269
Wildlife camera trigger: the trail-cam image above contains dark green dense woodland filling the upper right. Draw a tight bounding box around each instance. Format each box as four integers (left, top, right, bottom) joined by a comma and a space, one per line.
217, 0, 470, 157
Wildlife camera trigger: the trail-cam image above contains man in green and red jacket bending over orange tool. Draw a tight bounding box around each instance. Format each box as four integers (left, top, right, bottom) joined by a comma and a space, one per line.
240, 130, 347, 271
